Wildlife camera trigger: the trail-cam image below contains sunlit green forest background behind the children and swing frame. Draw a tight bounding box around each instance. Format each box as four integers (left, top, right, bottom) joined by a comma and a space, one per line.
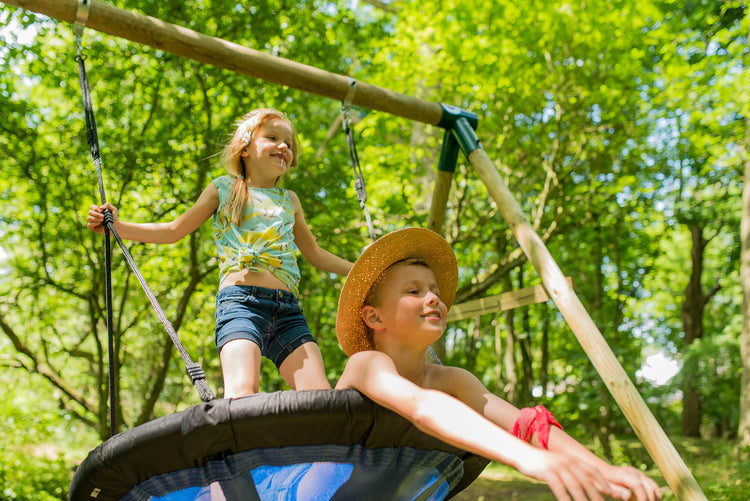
0, 0, 750, 500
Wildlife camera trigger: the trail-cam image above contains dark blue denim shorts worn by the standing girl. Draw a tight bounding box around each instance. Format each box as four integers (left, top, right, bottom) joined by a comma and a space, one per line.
216, 285, 315, 367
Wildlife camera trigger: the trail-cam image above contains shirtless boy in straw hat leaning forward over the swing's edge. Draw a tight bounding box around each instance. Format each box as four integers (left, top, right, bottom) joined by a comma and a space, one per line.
336, 228, 661, 501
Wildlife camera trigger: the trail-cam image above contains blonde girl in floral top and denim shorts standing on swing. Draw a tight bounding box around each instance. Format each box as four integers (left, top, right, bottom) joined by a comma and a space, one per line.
87, 108, 352, 398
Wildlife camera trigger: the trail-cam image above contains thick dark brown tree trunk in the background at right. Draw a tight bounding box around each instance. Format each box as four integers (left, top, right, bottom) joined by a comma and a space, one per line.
682, 223, 706, 437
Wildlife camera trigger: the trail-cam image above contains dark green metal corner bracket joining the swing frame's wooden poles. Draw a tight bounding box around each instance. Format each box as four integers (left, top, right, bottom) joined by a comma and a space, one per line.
438, 104, 482, 172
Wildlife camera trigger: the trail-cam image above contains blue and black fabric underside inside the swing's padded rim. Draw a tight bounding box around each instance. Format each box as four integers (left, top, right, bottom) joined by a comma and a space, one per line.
122, 445, 463, 501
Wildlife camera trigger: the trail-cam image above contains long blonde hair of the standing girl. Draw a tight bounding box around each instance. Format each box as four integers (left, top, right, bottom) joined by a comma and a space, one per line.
221, 108, 300, 226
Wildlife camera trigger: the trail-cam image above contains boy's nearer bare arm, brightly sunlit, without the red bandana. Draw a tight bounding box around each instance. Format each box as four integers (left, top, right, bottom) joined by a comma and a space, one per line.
336, 351, 630, 500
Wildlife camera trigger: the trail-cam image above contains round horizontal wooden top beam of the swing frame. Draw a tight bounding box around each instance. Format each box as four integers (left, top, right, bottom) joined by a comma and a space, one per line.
0, 0, 443, 125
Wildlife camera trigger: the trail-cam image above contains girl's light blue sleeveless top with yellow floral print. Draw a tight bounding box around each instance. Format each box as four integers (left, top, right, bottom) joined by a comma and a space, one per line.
212, 176, 300, 296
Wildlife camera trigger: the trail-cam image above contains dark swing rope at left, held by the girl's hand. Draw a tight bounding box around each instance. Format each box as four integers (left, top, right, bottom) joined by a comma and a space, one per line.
73, 0, 215, 435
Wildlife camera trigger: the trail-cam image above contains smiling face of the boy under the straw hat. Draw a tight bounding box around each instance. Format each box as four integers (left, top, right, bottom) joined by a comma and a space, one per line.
363, 263, 448, 339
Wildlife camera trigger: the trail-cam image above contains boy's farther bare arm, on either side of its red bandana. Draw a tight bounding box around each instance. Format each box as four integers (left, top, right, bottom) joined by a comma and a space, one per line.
450, 367, 661, 500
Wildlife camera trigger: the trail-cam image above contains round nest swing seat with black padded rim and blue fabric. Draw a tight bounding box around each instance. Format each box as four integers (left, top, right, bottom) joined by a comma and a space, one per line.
69, 390, 489, 501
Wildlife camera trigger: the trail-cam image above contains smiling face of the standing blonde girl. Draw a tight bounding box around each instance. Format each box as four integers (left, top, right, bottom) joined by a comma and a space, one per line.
240, 117, 294, 184
